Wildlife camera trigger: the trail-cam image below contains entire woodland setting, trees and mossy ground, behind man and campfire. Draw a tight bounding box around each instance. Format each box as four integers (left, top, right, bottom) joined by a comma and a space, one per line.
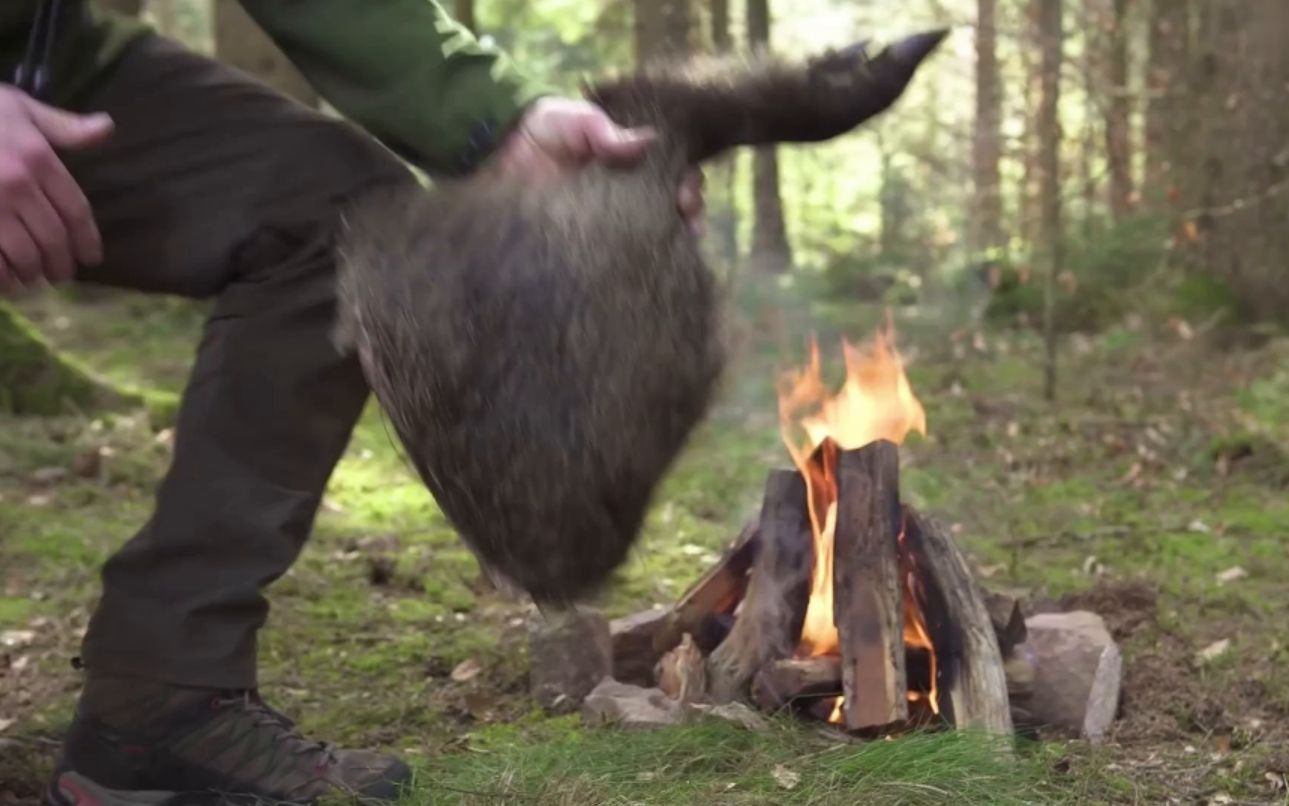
0, 0, 1289, 803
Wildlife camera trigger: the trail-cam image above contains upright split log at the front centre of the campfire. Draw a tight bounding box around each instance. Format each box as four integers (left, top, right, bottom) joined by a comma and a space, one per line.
833, 440, 909, 730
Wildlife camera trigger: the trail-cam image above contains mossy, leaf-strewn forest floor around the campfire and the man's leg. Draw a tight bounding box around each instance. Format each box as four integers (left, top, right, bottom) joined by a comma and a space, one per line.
0, 281, 1289, 805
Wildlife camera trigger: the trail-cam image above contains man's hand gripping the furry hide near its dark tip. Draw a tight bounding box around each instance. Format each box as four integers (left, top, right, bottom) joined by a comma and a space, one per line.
496, 98, 703, 235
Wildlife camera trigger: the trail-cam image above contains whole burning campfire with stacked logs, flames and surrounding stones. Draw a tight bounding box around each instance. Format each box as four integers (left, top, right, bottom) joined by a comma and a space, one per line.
534, 315, 1119, 735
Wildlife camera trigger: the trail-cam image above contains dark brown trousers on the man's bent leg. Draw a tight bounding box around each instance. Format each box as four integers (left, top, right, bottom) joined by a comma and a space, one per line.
56, 36, 412, 689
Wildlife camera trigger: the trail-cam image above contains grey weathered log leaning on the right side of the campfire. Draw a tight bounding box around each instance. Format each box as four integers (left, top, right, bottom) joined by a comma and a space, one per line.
905, 507, 1012, 735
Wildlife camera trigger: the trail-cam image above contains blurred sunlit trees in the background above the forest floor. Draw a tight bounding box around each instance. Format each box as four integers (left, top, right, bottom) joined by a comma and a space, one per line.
0, 0, 1289, 408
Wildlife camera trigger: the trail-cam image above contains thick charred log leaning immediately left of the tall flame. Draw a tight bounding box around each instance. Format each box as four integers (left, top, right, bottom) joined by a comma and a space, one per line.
708, 469, 815, 703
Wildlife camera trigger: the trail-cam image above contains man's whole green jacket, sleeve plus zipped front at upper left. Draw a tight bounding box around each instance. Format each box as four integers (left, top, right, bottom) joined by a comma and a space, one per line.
0, 0, 552, 175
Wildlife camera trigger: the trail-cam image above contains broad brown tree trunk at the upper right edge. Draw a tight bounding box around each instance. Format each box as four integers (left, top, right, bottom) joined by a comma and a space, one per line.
1195, 0, 1289, 321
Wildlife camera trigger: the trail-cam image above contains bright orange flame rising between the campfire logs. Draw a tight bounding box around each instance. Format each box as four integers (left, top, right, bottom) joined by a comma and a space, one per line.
779, 314, 938, 723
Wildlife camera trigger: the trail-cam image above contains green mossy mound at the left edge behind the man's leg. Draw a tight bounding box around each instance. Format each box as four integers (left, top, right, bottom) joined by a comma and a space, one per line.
0, 304, 142, 415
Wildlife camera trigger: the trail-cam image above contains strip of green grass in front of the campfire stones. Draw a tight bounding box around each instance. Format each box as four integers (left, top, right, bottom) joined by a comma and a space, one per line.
407, 718, 1060, 806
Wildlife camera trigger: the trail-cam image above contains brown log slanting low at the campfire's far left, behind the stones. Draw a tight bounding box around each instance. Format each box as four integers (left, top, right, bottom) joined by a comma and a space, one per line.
654, 521, 761, 656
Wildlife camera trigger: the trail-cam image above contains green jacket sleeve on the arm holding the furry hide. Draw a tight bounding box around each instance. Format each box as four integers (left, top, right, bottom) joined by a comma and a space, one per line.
241, 0, 554, 175
